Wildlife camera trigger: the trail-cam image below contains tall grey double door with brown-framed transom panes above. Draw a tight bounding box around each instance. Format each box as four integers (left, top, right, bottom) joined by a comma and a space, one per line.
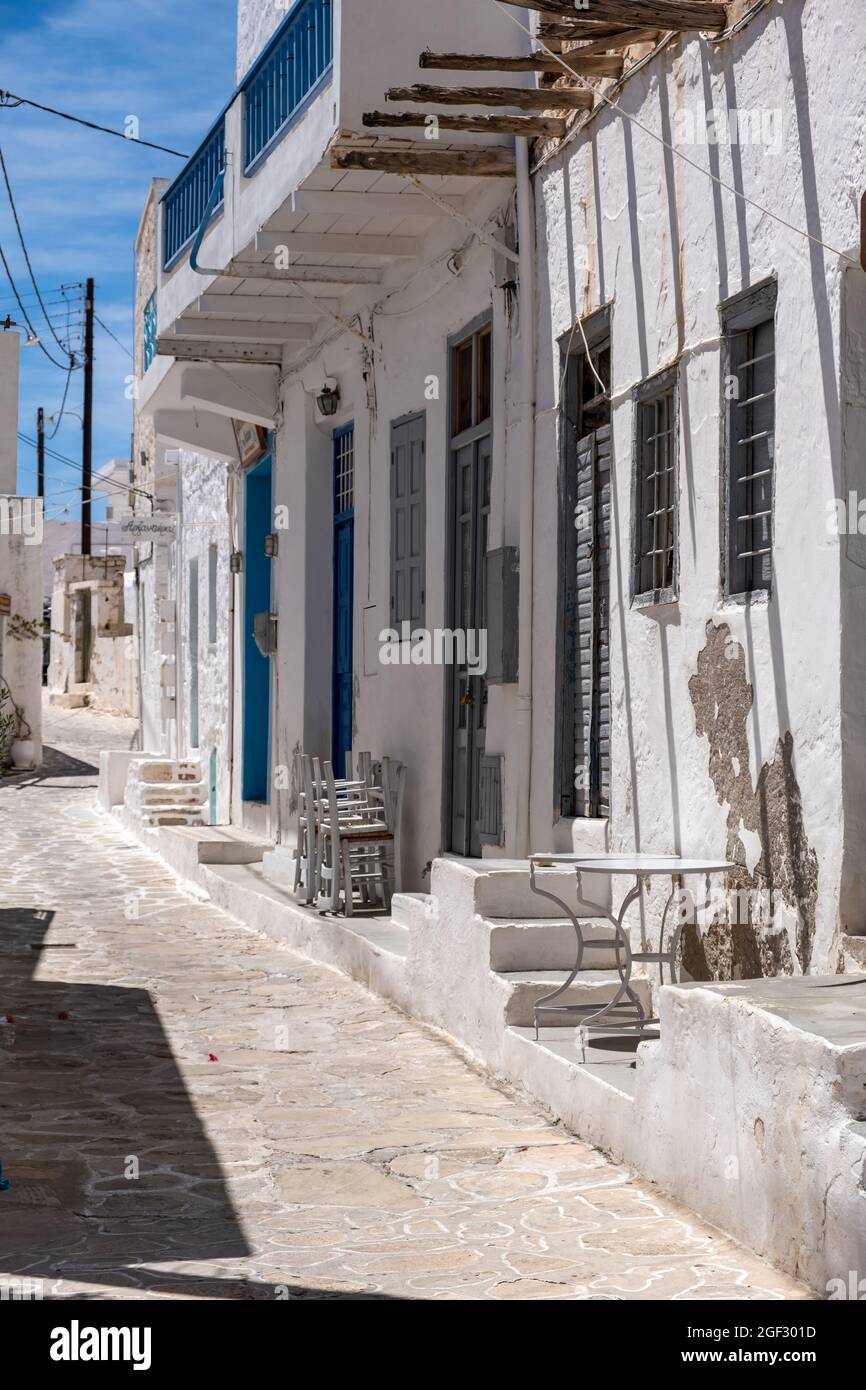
446, 320, 493, 858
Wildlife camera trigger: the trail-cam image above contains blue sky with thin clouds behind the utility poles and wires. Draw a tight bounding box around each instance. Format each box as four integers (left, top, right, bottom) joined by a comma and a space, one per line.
0, 0, 236, 517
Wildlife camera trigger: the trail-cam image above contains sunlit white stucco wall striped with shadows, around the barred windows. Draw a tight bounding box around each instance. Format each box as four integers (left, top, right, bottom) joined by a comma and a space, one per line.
532, 0, 866, 972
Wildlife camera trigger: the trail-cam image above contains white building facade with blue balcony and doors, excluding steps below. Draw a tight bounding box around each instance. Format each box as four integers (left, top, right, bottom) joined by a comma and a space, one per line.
130, 0, 866, 979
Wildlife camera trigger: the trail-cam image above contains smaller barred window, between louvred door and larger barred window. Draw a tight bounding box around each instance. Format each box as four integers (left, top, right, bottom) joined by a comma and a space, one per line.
632, 367, 678, 603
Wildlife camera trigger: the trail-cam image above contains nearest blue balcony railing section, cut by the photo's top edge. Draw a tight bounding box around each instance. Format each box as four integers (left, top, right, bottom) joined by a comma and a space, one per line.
243, 0, 334, 174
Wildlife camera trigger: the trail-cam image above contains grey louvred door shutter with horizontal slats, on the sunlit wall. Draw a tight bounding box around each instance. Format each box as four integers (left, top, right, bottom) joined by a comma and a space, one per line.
574, 425, 610, 816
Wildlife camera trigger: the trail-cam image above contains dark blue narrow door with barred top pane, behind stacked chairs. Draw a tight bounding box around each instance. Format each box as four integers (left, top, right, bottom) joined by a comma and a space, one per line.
331, 425, 354, 777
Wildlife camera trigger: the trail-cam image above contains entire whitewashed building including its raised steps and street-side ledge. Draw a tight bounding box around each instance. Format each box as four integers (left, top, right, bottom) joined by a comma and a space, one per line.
115, 0, 866, 1289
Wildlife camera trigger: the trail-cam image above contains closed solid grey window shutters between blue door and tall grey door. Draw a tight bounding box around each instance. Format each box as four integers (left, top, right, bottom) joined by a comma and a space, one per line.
391, 416, 427, 627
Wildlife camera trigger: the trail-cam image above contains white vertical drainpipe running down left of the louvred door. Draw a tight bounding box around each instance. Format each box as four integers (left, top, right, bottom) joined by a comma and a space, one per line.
513, 136, 535, 858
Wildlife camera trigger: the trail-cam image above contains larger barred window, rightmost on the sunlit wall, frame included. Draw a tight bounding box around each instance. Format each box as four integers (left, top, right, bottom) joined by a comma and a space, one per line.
721, 284, 776, 595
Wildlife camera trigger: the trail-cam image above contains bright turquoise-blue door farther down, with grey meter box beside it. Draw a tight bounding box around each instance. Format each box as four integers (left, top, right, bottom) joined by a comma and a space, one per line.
240, 456, 271, 801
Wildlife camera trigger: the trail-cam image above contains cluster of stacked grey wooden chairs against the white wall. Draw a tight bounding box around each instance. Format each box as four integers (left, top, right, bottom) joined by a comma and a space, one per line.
287, 753, 405, 917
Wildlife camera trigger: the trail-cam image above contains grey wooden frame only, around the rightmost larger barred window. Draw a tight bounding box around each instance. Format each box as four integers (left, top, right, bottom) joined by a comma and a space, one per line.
719, 277, 778, 603
